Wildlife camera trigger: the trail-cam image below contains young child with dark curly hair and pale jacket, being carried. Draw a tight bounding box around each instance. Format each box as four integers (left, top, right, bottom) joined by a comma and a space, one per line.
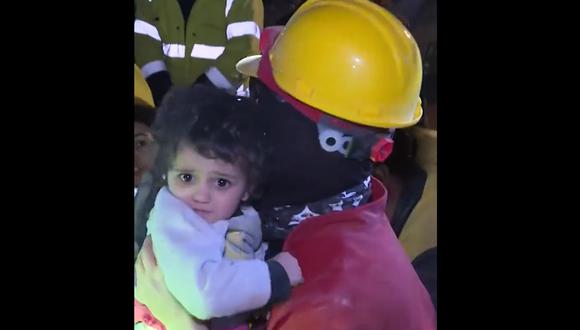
135, 86, 301, 329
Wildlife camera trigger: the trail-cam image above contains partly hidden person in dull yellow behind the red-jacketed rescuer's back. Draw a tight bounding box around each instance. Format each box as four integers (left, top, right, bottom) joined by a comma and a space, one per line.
373, 118, 437, 308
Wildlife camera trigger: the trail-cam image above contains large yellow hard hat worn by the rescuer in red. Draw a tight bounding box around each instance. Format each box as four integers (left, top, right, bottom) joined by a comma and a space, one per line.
238, 0, 423, 128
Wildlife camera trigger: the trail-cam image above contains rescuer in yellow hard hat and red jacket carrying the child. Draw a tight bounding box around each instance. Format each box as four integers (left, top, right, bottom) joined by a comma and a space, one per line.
136, 0, 436, 330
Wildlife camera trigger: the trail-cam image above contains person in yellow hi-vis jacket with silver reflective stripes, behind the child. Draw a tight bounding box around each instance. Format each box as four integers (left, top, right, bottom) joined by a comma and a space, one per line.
134, 0, 264, 105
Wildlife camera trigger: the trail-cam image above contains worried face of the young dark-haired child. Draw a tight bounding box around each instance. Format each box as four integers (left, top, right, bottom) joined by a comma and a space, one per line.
167, 143, 249, 223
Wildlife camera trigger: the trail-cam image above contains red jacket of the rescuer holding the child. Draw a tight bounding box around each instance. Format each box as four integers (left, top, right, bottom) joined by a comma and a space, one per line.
268, 178, 436, 330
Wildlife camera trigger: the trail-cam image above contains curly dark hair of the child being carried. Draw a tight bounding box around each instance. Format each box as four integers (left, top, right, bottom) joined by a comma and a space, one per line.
152, 85, 265, 200
